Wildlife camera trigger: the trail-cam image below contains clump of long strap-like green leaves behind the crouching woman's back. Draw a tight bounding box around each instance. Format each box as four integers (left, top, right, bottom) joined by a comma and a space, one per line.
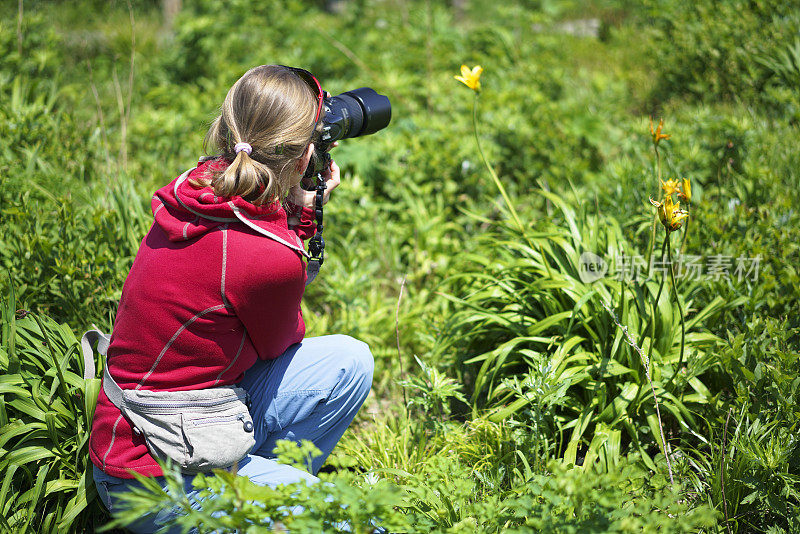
0, 284, 105, 532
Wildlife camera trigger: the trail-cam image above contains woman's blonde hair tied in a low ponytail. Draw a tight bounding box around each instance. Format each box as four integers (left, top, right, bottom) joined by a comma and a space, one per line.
198, 65, 322, 204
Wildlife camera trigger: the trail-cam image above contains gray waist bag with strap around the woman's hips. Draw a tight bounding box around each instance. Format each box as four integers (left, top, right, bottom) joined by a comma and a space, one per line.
81, 330, 255, 473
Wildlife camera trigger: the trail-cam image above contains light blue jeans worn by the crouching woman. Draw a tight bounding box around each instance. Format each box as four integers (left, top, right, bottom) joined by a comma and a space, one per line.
94, 335, 374, 533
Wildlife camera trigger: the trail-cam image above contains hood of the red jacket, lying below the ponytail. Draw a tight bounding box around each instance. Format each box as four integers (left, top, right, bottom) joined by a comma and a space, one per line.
151, 158, 308, 257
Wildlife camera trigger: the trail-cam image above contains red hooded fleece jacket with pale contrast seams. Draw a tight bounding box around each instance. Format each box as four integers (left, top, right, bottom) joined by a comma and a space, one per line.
89, 159, 316, 478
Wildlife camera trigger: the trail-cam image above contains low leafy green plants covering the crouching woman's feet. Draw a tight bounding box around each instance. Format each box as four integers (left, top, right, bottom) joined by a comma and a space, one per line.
105, 441, 408, 533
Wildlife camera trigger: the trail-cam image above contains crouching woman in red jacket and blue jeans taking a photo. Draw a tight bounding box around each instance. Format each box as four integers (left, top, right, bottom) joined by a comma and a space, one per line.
90, 65, 373, 532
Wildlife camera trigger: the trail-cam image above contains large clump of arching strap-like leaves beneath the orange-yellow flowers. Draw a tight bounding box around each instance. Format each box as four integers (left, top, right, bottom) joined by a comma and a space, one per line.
438, 191, 737, 468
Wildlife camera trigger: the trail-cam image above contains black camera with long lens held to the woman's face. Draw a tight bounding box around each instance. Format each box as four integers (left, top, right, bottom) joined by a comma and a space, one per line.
304, 87, 392, 182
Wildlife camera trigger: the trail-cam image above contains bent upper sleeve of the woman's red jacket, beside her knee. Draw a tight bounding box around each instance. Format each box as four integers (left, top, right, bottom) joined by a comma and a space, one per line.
226, 237, 306, 360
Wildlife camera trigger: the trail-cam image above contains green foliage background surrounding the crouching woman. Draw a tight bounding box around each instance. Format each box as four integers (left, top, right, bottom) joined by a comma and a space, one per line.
0, 0, 800, 532
